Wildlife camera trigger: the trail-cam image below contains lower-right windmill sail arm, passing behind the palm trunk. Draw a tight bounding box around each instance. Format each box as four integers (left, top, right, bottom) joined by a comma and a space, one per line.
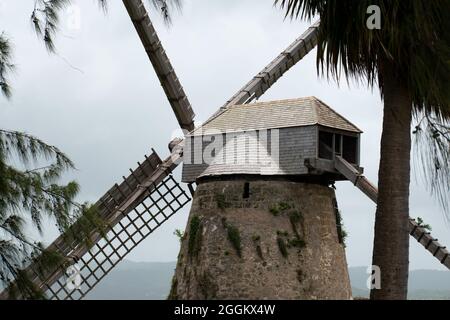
335, 156, 450, 269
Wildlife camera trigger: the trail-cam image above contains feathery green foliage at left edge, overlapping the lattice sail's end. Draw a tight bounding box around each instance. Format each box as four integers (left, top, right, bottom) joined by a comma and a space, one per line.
0, 130, 103, 298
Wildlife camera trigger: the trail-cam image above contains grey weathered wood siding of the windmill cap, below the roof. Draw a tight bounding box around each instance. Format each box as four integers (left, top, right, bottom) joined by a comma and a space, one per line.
182, 126, 317, 182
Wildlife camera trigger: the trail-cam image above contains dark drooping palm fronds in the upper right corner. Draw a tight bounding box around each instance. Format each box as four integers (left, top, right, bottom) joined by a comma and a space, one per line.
275, 0, 450, 115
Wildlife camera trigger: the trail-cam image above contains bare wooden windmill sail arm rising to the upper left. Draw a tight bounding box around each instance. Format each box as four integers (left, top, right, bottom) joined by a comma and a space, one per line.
123, 0, 195, 131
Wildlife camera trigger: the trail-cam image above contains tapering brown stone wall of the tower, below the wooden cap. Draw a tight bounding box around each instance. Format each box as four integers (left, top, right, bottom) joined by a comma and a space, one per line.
169, 180, 351, 299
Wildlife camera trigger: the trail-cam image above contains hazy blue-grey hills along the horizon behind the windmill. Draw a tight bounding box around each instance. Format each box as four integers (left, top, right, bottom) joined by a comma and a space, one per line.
86, 261, 450, 300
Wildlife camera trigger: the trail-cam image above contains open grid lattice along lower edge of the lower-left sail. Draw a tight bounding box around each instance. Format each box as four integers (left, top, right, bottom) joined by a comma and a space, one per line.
47, 175, 190, 300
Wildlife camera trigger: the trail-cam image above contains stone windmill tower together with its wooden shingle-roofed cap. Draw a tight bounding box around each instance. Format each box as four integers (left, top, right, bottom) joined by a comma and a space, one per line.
169, 97, 361, 299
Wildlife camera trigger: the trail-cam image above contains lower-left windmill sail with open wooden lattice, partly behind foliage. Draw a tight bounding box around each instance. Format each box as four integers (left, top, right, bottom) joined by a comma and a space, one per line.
0, 148, 190, 300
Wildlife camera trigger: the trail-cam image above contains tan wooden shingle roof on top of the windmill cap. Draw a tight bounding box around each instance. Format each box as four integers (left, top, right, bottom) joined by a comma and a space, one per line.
191, 97, 362, 135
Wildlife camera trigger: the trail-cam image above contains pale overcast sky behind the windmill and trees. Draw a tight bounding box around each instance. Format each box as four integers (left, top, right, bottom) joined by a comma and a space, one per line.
0, 0, 450, 269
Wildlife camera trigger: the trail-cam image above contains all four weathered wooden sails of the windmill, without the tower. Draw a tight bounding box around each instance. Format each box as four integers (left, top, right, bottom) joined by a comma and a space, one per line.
0, 0, 450, 300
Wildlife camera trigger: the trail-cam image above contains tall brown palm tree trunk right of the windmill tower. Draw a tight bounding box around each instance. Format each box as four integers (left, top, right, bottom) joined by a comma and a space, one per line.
370, 61, 412, 300
